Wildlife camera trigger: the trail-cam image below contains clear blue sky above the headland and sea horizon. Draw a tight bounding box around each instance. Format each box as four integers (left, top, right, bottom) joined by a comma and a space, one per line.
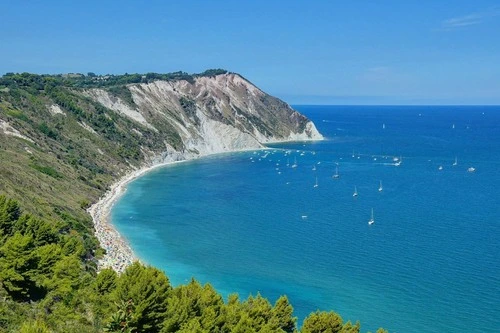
0, 0, 500, 104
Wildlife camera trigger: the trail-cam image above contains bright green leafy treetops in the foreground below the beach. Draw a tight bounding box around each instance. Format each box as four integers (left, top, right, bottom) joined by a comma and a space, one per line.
0, 195, 383, 333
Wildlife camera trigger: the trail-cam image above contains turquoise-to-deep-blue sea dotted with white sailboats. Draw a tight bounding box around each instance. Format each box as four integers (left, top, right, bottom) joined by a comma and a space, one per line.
112, 106, 500, 332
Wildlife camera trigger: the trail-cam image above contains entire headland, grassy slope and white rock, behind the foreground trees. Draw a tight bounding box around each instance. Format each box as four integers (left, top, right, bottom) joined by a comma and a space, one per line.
0, 70, 322, 221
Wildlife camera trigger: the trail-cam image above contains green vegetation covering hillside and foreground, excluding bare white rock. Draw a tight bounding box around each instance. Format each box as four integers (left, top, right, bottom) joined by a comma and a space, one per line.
0, 69, 384, 333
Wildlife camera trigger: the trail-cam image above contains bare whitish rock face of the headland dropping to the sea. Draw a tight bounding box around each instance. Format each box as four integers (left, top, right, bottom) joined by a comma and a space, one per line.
84, 74, 323, 161
